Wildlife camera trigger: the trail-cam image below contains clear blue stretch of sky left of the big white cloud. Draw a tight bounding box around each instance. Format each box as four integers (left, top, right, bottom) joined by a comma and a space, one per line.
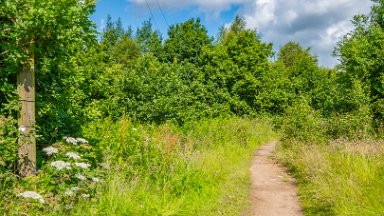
91, 0, 239, 37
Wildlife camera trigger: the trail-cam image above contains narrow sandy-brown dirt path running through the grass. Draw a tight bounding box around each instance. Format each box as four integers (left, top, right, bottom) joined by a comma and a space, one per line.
247, 142, 303, 216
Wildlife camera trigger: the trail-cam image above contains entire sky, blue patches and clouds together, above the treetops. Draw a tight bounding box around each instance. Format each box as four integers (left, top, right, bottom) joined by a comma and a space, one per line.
91, 0, 372, 67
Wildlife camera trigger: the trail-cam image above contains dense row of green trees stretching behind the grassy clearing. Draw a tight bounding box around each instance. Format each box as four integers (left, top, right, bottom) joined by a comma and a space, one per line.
0, 0, 384, 164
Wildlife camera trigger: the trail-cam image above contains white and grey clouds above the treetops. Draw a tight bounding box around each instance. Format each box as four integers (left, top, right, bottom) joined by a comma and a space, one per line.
127, 0, 372, 66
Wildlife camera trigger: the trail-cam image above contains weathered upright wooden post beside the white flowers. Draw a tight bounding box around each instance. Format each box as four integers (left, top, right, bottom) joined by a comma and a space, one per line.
17, 55, 36, 177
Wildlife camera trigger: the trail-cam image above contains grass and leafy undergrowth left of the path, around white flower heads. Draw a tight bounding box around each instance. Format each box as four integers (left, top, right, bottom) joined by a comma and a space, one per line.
0, 118, 274, 215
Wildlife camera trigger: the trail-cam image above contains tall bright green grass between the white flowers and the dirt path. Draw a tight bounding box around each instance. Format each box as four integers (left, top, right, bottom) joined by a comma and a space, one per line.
72, 118, 274, 215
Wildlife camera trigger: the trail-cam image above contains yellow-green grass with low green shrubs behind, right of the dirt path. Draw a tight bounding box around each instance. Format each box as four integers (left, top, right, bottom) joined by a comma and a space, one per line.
277, 103, 384, 216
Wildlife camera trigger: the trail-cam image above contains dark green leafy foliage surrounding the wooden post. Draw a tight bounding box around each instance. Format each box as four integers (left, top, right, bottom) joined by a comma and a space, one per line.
0, 0, 96, 142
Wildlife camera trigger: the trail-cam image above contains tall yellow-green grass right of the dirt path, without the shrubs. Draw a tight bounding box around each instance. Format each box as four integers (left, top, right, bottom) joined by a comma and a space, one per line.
278, 140, 384, 215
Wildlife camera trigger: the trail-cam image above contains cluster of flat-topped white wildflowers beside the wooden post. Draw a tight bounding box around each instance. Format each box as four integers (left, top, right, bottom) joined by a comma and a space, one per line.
17, 137, 101, 207
